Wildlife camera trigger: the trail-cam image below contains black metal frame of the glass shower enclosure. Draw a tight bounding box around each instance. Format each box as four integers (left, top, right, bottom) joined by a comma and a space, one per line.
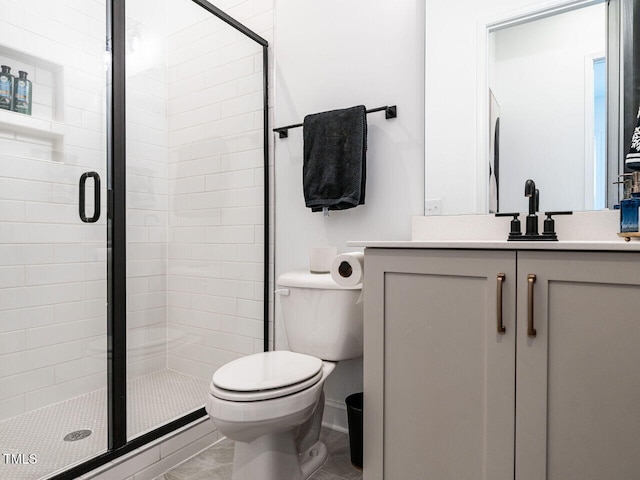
49, 0, 269, 480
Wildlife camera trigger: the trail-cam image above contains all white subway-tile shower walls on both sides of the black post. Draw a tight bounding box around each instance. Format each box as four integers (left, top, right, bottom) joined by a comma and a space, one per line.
0, 0, 273, 426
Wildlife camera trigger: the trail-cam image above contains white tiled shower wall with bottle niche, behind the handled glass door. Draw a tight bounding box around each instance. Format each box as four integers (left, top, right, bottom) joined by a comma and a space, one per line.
0, 0, 106, 420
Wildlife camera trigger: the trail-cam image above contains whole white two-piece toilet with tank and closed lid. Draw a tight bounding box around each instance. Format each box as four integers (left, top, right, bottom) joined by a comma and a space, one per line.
206, 272, 363, 480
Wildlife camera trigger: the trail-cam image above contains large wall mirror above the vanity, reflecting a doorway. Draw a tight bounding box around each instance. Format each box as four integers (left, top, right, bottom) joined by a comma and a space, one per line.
425, 0, 638, 214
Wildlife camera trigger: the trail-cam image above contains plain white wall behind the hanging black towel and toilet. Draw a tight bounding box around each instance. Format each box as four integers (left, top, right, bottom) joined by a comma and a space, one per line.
274, 0, 424, 428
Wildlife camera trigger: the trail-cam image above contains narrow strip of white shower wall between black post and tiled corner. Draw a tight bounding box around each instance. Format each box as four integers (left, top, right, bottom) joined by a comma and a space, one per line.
126, 0, 169, 379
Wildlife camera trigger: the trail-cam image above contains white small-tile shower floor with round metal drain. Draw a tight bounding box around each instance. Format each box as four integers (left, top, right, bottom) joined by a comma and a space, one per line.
0, 370, 209, 480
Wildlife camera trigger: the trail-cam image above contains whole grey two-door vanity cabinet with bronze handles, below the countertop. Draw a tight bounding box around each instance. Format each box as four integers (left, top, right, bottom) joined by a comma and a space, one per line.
364, 248, 640, 480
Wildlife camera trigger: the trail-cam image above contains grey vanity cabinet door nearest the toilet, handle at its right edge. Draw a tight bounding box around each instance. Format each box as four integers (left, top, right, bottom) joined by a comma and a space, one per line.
364, 249, 515, 480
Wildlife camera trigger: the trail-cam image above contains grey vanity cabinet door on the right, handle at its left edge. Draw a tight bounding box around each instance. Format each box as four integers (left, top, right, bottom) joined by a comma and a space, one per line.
516, 252, 640, 480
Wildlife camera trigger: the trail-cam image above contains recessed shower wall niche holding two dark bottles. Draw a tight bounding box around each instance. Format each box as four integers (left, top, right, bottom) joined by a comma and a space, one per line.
0, 44, 64, 123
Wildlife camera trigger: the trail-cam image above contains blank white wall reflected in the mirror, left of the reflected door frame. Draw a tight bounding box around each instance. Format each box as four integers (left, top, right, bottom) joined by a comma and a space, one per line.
425, 0, 608, 214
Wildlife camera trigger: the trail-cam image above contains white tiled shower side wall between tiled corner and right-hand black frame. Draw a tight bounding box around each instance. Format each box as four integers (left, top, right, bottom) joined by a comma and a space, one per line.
168, 3, 264, 378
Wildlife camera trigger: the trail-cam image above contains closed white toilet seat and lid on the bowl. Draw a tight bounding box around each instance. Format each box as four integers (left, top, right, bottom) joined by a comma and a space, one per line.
210, 351, 323, 402
